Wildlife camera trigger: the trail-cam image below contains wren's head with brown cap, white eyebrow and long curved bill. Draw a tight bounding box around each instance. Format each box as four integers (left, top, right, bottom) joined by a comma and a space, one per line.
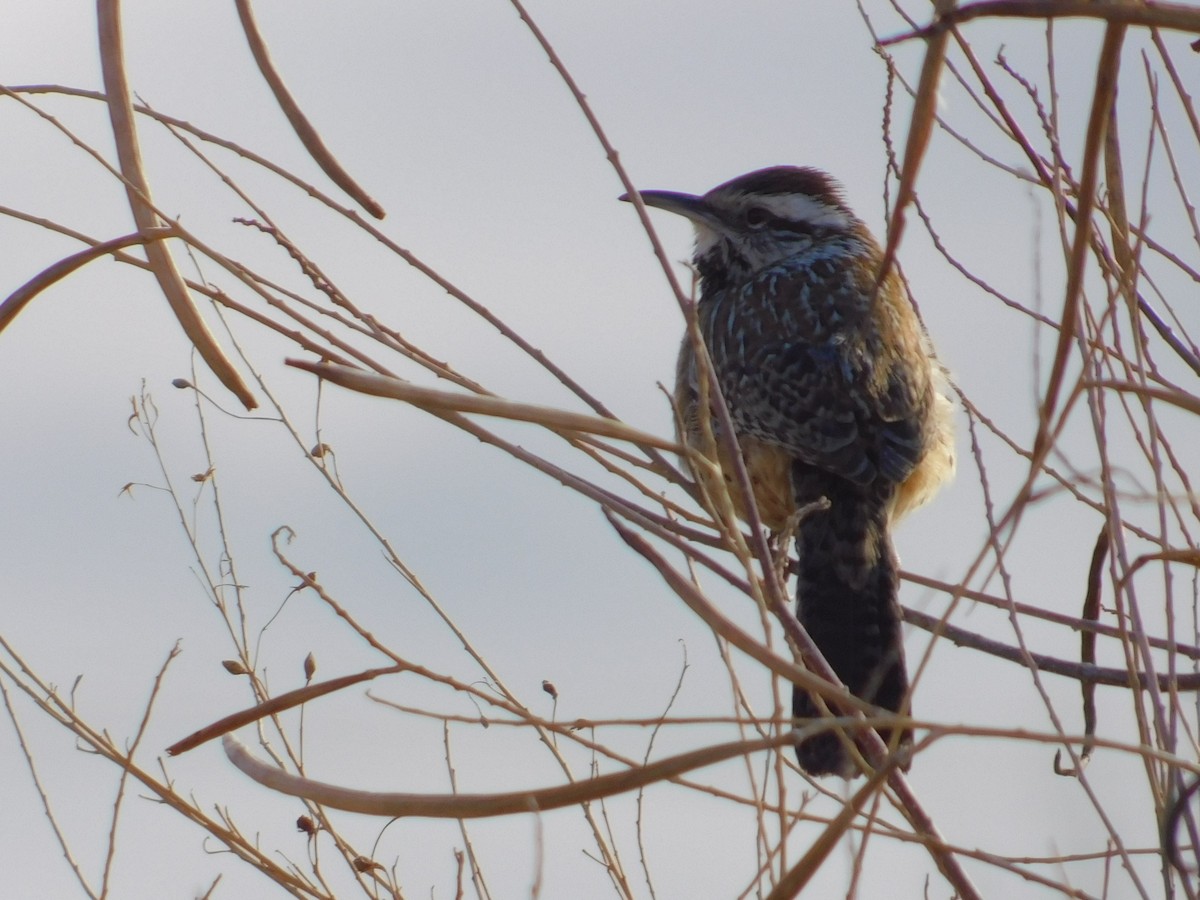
620, 166, 860, 284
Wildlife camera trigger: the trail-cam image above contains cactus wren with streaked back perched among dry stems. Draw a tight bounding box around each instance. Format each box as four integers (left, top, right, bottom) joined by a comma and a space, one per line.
623, 167, 954, 778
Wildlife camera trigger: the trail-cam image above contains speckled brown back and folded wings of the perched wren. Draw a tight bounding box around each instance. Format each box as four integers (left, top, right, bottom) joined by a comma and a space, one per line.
708, 260, 931, 485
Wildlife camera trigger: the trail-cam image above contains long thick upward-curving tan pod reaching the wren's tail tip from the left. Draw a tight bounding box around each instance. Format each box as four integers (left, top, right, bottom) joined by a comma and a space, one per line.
223, 732, 794, 818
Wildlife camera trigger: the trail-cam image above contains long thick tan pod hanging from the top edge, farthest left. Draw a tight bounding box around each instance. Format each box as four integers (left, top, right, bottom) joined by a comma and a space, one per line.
96, 0, 257, 409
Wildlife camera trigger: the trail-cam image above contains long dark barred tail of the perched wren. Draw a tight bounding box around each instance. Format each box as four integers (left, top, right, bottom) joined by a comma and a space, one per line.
792, 464, 912, 778
